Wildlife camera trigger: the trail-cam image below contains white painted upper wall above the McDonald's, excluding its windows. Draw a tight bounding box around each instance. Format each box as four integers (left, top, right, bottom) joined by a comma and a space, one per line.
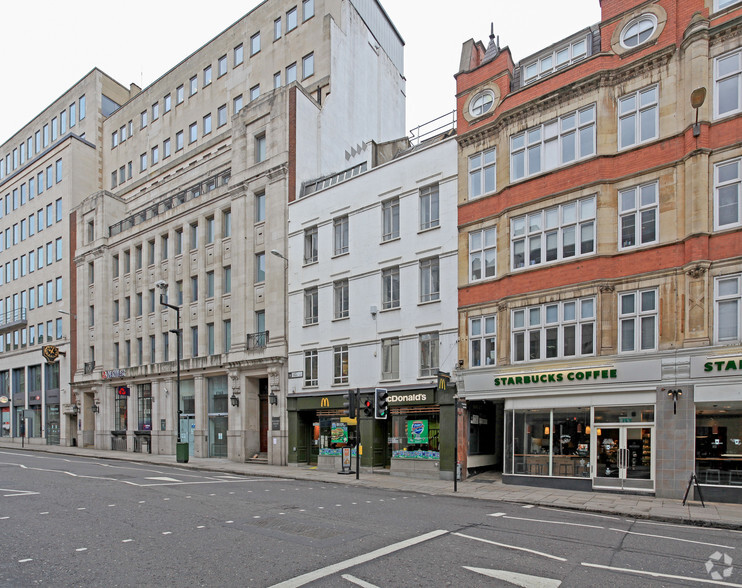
288, 139, 458, 393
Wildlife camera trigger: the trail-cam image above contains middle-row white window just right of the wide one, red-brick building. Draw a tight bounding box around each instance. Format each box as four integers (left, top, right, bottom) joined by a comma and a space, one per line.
618, 182, 659, 249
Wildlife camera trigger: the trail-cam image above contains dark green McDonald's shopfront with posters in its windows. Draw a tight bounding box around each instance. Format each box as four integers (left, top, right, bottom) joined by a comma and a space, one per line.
288, 388, 454, 480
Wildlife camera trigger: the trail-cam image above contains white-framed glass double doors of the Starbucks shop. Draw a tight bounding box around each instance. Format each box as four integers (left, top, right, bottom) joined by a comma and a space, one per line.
593, 427, 654, 490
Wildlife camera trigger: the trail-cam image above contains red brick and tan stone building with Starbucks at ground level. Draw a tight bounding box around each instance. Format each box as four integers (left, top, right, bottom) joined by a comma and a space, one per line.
457, 0, 742, 500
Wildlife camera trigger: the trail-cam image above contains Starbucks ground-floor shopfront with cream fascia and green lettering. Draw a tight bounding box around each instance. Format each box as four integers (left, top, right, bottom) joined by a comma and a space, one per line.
459, 346, 742, 502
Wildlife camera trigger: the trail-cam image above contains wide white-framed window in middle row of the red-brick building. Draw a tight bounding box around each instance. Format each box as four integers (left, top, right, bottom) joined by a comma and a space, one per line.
510, 196, 596, 269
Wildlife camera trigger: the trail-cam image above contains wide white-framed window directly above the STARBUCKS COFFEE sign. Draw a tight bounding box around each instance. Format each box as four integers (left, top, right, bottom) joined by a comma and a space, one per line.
511, 298, 595, 362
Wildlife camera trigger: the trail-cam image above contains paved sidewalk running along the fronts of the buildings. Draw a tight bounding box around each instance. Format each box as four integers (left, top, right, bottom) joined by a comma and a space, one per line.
0, 440, 742, 530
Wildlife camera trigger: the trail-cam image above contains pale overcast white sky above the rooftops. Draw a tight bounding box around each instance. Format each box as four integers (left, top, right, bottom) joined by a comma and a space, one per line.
0, 0, 600, 144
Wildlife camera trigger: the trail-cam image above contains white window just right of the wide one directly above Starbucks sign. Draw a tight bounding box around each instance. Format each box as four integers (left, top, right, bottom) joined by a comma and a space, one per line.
618, 289, 658, 353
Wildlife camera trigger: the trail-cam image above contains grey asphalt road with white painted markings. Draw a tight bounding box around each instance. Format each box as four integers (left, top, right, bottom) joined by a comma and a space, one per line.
0, 450, 742, 588
